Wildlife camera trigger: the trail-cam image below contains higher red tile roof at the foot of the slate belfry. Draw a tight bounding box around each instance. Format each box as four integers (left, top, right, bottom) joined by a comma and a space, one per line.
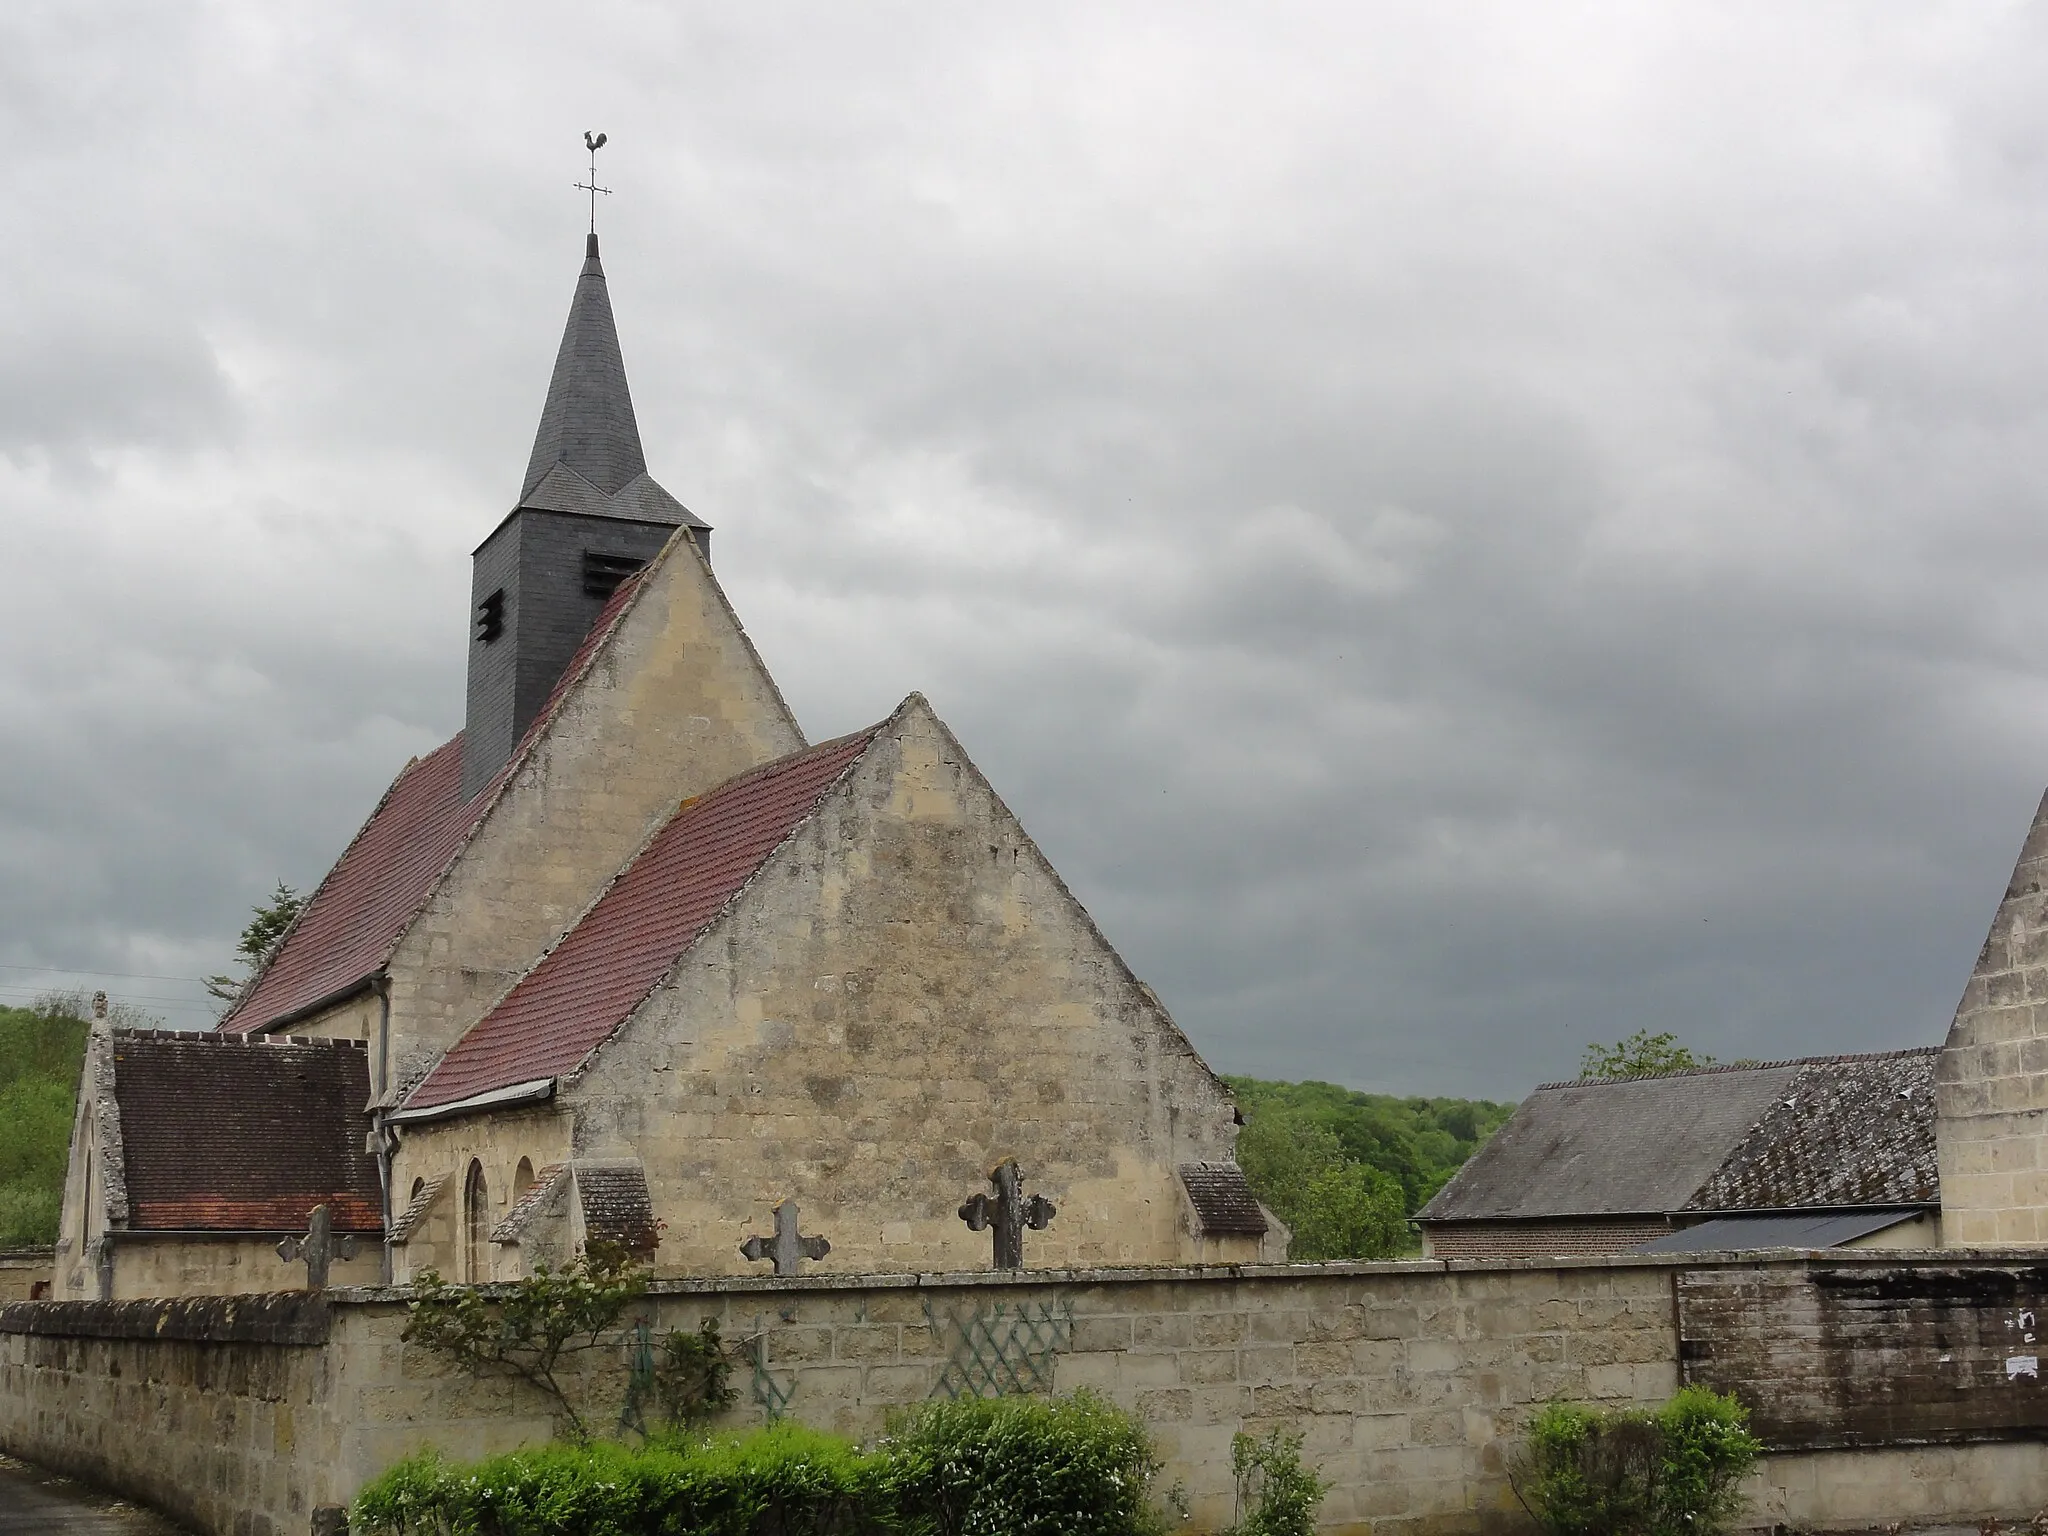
221, 575, 639, 1034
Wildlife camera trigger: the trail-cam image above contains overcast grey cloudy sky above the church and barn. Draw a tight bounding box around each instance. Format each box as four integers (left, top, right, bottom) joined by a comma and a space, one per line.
0, 0, 2048, 1098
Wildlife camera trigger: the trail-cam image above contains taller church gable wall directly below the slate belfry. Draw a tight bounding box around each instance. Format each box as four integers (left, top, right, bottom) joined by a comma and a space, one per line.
387, 537, 803, 1087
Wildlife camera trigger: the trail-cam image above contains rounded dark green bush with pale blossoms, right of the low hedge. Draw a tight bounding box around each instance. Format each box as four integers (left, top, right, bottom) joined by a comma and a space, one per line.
883, 1393, 1163, 1536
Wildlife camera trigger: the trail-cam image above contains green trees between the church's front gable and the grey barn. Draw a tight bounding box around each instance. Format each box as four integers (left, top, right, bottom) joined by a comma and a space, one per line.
1229, 1077, 1513, 1260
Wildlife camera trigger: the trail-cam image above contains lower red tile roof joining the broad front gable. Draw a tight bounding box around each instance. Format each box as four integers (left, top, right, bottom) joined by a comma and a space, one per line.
406, 725, 881, 1110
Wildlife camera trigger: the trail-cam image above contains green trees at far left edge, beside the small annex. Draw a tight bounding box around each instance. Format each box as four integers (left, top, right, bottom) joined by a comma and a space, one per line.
0, 995, 88, 1249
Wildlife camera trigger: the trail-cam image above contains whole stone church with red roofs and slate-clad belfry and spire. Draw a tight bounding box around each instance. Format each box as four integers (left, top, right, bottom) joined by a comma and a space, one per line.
57, 236, 1284, 1296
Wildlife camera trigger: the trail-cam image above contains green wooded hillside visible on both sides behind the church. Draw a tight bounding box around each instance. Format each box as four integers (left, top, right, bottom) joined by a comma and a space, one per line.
0, 1011, 1516, 1260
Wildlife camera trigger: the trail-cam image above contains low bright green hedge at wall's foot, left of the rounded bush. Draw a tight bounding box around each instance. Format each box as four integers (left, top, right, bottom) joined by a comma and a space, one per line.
348, 1423, 891, 1536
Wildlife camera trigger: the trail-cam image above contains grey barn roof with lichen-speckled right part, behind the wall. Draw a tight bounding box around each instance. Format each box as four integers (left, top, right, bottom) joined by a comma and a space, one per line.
1417, 1047, 1942, 1223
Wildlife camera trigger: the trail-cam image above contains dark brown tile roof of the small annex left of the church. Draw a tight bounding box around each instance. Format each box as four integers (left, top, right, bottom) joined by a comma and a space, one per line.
111, 1030, 383, 1236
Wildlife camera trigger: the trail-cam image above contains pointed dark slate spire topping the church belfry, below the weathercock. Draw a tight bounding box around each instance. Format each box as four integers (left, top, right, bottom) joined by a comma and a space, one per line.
518, 236, 647, 504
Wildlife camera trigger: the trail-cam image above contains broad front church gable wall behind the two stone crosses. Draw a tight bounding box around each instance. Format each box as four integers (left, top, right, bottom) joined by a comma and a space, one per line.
563, 700, 1228, 1274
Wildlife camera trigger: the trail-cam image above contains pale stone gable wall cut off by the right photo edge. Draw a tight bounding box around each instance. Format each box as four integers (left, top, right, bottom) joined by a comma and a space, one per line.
1935, 799, 2048, 1247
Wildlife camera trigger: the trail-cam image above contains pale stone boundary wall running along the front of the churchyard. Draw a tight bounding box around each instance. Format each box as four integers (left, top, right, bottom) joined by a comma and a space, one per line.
0, 1251, 2048, 1536
